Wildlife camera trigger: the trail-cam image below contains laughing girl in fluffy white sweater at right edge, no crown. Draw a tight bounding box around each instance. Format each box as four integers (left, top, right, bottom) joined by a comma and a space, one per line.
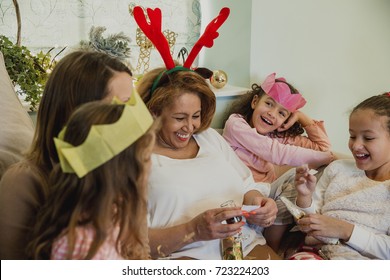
295, 93, 390, 259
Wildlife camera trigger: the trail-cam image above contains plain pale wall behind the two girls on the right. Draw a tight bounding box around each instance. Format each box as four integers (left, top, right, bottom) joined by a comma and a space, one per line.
205, 0, 390, 153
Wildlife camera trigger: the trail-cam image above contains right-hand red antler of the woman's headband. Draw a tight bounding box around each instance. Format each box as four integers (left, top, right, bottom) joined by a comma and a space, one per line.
183, 7, 230, 68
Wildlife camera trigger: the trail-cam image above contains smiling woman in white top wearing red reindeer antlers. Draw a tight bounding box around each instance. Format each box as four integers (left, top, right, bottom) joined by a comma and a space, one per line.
134, 7, 277, 259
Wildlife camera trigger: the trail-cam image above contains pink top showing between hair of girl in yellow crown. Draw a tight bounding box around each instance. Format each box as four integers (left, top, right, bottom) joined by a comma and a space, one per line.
51, 226, 123, 260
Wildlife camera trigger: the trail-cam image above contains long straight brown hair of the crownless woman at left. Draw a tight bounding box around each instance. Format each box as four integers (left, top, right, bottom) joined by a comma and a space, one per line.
26, 50, 132, 182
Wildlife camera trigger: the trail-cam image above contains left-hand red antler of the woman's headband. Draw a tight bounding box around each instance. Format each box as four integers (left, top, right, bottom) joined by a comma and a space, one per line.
133, 6, 175, 69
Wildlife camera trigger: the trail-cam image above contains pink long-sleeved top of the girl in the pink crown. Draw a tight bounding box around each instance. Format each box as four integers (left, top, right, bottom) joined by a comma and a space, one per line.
223, 114, 333, 183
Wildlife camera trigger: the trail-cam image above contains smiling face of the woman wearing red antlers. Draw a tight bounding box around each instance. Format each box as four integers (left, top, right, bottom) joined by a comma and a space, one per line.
159, 93, 201, 149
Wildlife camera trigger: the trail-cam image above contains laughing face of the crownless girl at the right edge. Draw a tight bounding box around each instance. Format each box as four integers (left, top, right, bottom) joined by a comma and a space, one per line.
348, 109, 390, 179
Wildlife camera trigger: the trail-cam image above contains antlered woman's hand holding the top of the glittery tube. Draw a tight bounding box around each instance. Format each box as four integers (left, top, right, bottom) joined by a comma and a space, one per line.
190, 207, 245, 241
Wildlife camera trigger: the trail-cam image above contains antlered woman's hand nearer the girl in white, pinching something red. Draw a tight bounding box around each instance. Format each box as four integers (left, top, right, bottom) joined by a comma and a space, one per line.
244, 196, 278, 227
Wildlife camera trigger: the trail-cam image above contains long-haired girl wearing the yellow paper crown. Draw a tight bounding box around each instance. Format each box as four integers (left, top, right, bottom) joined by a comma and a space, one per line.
29, 97, 155, 259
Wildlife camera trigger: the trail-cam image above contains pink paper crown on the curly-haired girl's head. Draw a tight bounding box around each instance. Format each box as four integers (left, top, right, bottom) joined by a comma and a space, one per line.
261, 73, 306, 112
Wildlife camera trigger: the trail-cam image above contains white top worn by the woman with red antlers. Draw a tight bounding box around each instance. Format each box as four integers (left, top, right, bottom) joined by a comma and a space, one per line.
148, 128, 270, 259
